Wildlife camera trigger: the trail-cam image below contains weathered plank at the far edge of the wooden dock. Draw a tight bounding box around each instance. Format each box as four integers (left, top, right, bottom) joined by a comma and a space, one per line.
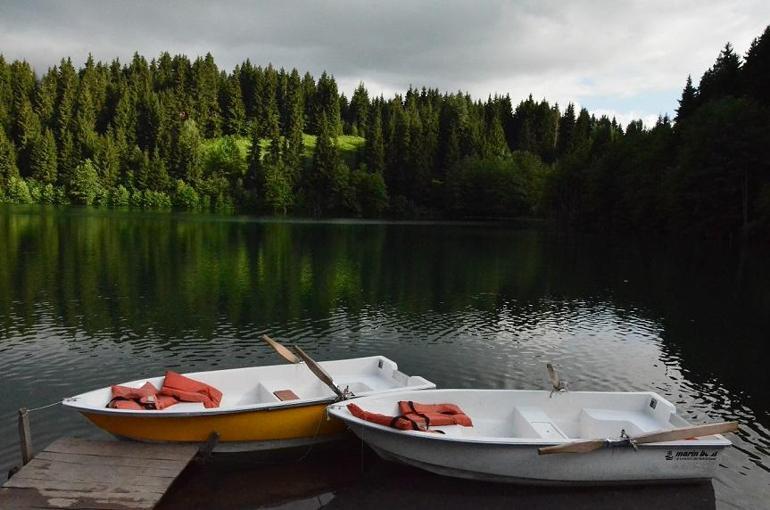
45, 437, 198, 462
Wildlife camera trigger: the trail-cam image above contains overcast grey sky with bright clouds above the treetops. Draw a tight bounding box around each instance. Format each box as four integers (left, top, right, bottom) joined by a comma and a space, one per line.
0, 0, 770, 123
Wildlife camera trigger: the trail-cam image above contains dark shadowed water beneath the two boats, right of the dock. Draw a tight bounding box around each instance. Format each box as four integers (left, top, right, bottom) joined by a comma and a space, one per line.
159, 441, 716, 510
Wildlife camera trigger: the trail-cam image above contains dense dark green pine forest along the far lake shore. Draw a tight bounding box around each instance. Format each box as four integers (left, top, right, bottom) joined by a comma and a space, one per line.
0, 27, 770, 237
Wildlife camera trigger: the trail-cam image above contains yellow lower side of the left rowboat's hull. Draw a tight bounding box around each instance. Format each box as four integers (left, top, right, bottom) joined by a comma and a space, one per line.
83, 404, 345, 442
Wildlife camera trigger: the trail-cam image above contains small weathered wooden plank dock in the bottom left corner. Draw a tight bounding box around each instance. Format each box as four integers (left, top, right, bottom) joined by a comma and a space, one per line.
0, 438, 198, 510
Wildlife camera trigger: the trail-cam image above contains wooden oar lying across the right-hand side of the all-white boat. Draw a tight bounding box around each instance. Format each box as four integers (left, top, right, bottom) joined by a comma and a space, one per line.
537, 421, 738, 455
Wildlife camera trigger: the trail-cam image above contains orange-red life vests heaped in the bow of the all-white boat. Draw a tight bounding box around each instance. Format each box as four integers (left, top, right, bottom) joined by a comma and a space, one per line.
347, 401, 473, 432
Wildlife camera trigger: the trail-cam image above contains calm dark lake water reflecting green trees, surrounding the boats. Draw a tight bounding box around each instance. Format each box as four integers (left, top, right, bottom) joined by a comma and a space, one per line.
0, 207, 770, 509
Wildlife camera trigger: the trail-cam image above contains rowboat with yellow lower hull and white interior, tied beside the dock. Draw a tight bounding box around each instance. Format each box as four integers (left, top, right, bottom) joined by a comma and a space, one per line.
62, 356, 436, 451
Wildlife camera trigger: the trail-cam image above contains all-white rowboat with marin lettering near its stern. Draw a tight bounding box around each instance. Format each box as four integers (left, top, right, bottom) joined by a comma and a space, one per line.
328, 390, 737, 484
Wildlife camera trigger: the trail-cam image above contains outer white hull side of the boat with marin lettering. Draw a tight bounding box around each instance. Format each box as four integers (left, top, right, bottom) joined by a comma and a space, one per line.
350, 425, 722, 485
